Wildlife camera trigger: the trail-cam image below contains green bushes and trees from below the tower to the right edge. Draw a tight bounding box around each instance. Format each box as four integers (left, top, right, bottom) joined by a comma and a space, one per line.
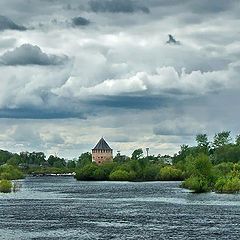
75, 131, 240, 193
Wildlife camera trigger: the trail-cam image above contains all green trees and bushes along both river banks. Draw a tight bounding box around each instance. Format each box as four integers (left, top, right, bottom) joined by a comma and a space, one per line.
0, 131, 240, 193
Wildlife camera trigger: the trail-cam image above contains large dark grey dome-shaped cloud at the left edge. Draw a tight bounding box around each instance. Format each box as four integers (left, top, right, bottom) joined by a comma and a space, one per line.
0, 44, 68, 66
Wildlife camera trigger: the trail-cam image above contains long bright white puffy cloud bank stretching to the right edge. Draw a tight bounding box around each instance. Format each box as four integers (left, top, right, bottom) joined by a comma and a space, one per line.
53, 65, 239, 98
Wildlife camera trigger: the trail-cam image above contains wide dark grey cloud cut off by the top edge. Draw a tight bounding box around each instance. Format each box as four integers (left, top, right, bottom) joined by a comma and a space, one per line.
89, 0, 150, 13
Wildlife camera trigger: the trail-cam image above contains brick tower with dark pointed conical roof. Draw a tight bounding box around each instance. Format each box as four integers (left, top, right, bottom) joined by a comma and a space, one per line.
92, 138, 113, 164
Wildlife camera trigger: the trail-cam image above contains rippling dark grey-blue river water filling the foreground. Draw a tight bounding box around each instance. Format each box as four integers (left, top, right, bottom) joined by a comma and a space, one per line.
0, 176, 240, 240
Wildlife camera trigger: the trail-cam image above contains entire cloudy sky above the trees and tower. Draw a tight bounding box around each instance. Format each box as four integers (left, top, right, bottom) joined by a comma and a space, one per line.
0, 0, 240, 159
